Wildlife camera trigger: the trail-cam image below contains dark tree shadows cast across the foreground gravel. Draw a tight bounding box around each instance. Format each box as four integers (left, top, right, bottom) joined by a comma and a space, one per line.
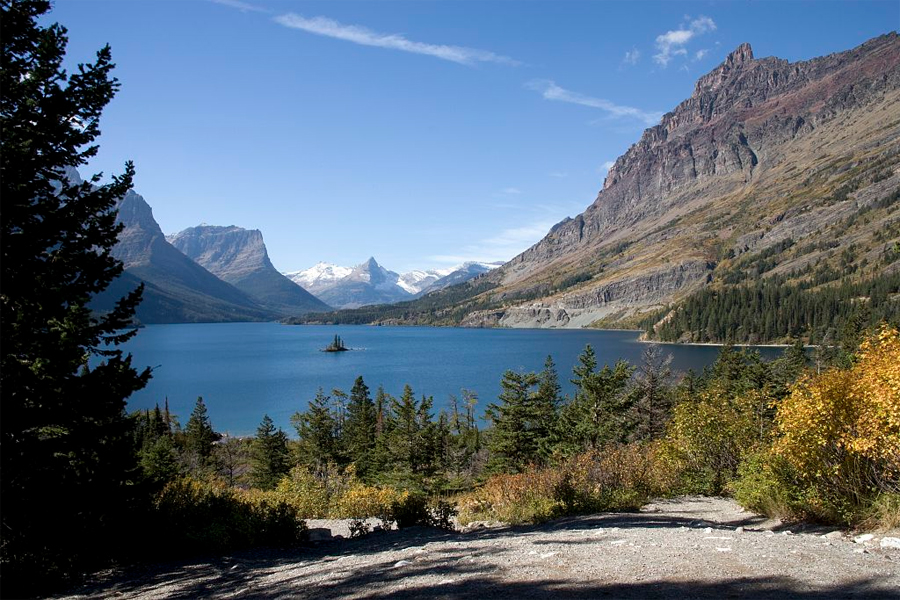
59, 513, 884, 600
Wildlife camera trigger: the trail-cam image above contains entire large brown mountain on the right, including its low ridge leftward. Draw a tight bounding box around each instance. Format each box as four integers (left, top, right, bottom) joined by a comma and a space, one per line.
290, 33, 900, 340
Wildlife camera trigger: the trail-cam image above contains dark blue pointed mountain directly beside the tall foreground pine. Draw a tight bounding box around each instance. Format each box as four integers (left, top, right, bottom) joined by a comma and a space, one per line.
95, 191, 276, 323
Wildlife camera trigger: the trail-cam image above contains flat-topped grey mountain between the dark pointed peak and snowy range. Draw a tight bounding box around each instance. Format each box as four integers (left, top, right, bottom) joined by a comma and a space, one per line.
166, 225, 330, 316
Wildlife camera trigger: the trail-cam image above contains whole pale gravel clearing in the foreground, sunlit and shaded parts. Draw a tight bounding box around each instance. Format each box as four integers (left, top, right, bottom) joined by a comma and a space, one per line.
56, 497, 900, 600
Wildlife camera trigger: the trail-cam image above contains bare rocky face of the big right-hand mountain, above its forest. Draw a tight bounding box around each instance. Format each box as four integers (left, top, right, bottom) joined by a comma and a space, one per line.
466, 33, 900, 326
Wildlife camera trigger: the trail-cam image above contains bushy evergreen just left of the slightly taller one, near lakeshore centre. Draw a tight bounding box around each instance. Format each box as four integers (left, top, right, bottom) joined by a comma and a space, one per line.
487, 371, 538, 473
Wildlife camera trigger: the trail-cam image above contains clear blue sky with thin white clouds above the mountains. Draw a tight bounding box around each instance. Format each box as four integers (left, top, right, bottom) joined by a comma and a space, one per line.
51, 0, 900, 272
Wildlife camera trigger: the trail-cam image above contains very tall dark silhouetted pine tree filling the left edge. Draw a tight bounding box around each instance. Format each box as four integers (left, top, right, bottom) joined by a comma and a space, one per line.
0, 0, 150, 596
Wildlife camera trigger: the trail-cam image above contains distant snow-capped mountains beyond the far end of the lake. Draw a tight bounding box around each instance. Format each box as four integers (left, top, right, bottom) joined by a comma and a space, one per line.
285, 258, 502, 308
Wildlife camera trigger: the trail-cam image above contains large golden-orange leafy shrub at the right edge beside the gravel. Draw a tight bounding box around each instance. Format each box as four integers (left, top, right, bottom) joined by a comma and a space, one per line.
773, 327, 900, 523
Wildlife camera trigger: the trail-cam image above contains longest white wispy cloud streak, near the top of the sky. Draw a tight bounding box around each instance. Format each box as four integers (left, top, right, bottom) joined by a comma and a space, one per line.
275, 13, 521, 66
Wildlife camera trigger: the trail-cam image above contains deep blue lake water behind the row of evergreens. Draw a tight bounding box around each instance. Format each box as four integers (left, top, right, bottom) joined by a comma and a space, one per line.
125, 323, 780, 436
